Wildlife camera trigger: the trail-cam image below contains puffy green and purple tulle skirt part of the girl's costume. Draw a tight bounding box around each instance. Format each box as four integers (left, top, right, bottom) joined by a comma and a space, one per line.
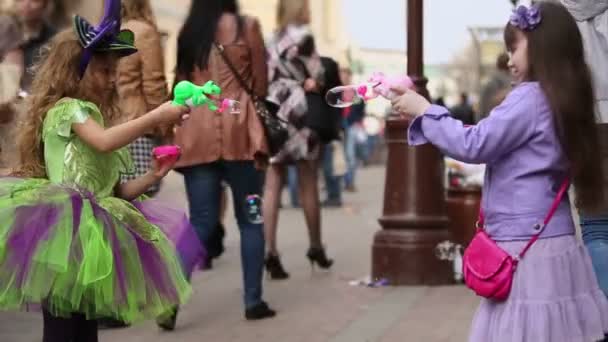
0, 178, 191, 322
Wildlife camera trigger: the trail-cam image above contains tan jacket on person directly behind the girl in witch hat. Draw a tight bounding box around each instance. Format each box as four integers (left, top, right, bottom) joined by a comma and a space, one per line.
116, 20, 168, 125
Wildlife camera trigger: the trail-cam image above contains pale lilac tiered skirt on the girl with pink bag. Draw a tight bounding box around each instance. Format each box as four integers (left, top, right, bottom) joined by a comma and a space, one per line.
469, 236, 608, 342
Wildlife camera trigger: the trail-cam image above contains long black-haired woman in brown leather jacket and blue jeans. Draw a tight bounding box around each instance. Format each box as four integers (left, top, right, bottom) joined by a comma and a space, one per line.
175, 0, 275, 320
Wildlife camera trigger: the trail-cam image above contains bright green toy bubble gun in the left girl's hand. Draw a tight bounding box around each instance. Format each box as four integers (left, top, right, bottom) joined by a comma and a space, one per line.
173, 81, 222, 112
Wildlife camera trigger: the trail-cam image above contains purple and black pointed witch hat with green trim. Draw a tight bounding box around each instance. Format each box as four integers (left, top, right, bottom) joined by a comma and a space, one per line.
74, 0, 137, 77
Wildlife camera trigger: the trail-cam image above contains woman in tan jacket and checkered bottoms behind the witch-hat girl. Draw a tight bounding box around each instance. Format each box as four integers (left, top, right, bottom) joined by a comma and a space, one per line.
116, 0, 168, 196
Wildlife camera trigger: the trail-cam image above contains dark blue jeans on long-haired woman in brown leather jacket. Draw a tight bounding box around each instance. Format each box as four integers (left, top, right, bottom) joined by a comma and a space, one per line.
180, 161, 264, 308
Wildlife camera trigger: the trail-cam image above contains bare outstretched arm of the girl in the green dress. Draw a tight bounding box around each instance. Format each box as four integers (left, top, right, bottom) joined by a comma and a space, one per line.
72, 102, 189, 152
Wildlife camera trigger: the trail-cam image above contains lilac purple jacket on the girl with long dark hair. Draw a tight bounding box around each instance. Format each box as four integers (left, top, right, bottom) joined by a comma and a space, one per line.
408, 82, 574, 241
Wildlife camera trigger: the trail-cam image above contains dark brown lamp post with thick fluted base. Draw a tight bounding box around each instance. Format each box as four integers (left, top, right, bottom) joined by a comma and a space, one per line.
372, 0, 452, 285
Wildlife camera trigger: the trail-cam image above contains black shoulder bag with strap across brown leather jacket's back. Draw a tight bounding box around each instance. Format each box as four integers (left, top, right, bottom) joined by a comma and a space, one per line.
215, 44, 289, 155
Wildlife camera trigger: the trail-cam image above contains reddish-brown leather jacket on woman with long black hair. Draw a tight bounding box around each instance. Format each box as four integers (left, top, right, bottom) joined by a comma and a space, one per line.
174, 15, 268, 168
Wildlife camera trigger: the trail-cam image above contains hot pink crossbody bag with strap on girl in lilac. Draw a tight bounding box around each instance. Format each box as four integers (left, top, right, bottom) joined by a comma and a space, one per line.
463, 179, 570, 301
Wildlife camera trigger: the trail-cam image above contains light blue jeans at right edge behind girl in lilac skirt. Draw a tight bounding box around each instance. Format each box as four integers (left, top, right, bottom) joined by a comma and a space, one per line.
581, 215, 608, 296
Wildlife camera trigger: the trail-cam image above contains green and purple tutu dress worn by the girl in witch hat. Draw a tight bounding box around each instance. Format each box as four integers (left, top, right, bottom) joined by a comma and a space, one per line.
0, 98, 205, 322
